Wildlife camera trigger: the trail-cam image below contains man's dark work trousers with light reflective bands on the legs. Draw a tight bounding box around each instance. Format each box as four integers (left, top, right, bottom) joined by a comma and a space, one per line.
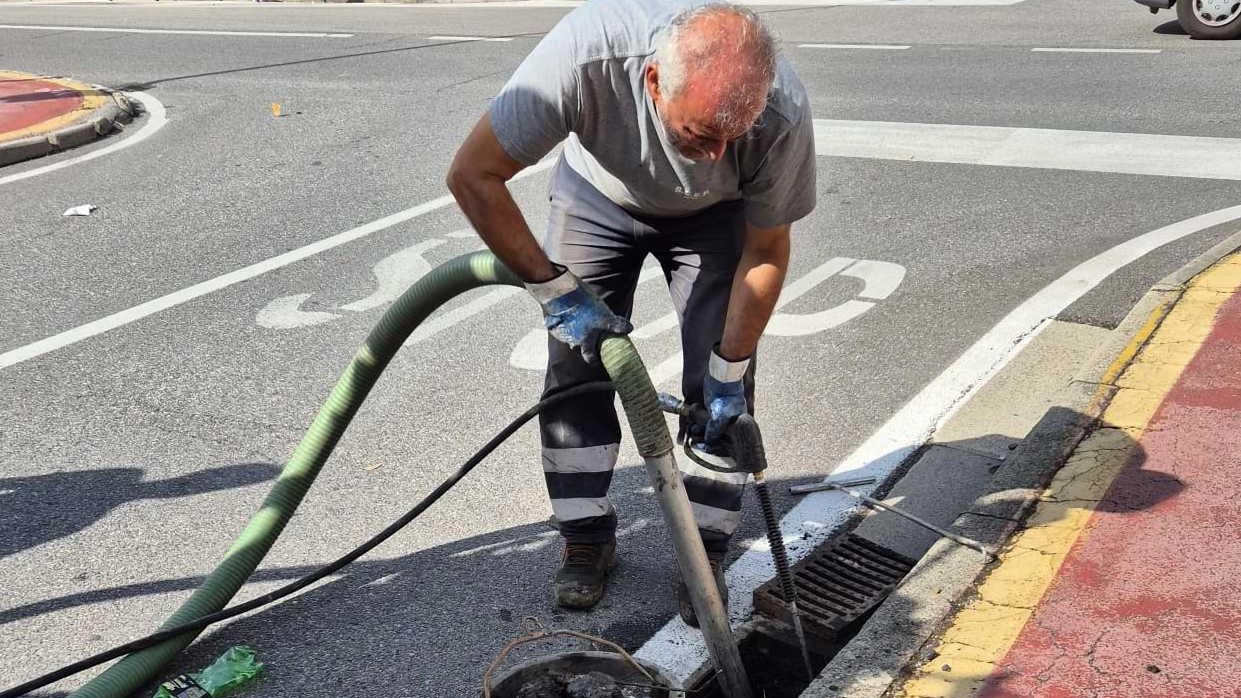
539, 160, 755, 554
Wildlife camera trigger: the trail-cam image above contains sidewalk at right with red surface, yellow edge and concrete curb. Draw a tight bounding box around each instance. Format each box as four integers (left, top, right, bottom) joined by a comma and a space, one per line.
803, 247, 1241, 698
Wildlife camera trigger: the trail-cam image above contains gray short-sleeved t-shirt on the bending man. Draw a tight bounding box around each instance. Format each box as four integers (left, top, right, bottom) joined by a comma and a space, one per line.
490, 0, 815, 227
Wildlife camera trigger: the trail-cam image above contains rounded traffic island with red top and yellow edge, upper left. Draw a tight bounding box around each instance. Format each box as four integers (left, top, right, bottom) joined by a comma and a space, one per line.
0, 71, 137, 166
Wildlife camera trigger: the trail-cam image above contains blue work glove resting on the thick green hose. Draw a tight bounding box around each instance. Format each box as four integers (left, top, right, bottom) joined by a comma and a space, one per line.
526, 267, 633, 364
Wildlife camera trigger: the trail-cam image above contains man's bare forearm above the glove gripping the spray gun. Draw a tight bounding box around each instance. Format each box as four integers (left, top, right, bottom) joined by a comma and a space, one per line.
720, 225, 792, 360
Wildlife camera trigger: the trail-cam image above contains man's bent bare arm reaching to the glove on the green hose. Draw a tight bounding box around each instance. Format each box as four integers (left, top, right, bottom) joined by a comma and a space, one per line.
448, 114, 556, 282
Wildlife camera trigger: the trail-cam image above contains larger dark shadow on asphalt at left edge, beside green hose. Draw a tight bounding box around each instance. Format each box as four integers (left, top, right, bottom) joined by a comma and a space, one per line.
0, 463, 280, 556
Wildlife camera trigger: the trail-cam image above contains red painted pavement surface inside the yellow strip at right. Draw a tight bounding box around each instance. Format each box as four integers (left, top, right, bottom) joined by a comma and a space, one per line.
977, 286, 1241, 698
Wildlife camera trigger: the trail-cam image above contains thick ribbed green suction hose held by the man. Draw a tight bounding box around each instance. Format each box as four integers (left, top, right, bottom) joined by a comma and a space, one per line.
69, 252, 673, 698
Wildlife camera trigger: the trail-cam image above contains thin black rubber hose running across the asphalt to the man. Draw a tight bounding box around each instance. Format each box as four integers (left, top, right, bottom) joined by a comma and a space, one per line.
0, 380, 614, 698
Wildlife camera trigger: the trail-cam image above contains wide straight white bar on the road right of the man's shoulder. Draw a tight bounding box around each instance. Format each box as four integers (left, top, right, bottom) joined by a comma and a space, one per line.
814, 119, 1241, 180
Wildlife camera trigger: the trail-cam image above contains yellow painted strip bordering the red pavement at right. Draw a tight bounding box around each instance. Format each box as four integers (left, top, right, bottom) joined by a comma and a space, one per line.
895, 253, 1241, 698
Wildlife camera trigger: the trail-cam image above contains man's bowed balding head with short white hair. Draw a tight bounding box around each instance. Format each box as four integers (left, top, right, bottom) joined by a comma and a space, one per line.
655, 2, 778, 128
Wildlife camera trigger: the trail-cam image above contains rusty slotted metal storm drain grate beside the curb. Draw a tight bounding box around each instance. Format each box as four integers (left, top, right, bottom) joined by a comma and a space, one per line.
755, 533, 915, 640
